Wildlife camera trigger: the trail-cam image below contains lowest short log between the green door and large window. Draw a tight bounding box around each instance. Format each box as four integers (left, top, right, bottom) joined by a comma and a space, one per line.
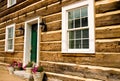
40, 42, 61, 51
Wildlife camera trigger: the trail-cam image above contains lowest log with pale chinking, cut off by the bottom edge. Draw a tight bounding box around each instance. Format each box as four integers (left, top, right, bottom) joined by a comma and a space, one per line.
45, 72, 102, 81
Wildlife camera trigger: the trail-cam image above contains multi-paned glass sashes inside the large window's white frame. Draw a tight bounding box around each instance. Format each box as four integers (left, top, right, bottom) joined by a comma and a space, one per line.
67, 6, 89, 49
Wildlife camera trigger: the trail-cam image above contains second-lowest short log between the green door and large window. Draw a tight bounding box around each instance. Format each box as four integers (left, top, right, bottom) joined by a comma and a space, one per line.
41, 32, 61, 42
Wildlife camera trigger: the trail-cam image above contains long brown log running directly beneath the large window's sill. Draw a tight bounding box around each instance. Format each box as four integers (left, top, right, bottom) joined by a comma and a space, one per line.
40, 52, 120, 68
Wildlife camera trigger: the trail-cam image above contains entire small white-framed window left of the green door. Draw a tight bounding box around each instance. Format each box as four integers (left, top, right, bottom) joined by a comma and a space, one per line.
5, 24, 15, 52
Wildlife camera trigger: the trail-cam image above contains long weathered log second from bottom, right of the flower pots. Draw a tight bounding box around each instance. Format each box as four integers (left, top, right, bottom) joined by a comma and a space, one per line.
41, 61, 120, 81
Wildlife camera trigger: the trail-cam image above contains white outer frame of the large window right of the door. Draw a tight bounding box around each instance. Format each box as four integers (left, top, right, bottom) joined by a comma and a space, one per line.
62, 0, 95, 54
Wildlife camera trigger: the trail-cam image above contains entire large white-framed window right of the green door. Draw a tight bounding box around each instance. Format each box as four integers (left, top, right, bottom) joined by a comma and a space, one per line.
62, 0, 95, 53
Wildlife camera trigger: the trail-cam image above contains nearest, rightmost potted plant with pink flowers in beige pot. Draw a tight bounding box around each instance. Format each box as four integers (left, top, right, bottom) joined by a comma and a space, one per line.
32, 66, 44, 81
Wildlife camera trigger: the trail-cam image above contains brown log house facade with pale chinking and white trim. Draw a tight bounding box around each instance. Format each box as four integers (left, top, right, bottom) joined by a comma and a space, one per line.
0, 0, 120, 81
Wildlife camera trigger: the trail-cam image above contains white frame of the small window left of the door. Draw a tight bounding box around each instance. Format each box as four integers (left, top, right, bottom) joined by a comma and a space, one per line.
5, 24, 15, 52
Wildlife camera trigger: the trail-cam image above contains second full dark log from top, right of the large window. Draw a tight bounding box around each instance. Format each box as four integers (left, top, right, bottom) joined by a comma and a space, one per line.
95, 13, 120, 27
